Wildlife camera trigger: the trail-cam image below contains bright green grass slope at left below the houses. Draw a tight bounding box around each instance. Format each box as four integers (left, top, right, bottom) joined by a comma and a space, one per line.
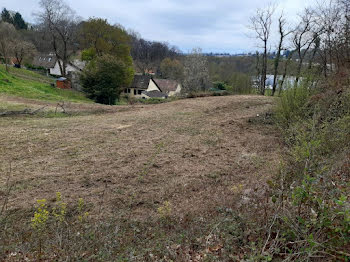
0, 65, 92, 103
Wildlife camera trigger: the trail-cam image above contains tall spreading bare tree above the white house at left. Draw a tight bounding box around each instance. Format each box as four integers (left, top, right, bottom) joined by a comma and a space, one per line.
36, 0, 78, 76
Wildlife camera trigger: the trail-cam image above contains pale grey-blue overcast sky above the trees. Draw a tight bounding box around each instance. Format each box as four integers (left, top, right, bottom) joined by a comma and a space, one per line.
0, 0, 315, 53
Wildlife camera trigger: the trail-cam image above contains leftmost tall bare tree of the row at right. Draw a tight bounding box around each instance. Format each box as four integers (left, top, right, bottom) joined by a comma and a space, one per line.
250, 5, 275, 95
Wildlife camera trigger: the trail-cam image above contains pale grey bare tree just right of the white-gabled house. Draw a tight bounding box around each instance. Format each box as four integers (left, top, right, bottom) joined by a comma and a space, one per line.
183, 48, 210, 93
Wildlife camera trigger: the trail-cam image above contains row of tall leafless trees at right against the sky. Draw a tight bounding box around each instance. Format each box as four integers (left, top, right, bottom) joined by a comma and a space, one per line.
250, 0, 350, 95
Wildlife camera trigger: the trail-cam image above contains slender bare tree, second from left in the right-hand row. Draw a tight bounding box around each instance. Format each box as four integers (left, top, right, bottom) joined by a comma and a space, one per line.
272, 13, 293, 96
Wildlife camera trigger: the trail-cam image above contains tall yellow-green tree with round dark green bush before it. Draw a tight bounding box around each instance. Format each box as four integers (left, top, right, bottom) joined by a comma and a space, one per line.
80, 18, 134, 105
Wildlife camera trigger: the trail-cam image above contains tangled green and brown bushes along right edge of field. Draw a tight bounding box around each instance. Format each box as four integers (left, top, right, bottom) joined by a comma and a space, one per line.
272, 77, 350, 261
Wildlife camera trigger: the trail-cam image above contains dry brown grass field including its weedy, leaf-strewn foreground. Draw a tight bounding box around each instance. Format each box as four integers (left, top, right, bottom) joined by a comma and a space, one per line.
0, 96, 281, 261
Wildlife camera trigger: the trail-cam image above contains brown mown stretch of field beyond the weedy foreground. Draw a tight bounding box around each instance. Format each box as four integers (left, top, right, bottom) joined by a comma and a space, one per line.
0, 96, 279, 219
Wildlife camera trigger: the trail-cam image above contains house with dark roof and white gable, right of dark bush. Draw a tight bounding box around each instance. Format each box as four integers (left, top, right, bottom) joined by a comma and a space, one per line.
123, 75, 181, 99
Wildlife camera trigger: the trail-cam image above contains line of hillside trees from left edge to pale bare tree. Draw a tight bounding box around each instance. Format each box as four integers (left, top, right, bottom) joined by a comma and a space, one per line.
0, 0, 210, 104
